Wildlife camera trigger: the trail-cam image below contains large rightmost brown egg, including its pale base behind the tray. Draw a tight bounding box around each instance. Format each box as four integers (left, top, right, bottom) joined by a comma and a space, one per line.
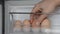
41, 19, 50, 33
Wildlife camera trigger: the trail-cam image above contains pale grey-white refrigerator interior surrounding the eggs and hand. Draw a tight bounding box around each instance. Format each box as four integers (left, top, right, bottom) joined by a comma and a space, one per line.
5, 1, 60, 34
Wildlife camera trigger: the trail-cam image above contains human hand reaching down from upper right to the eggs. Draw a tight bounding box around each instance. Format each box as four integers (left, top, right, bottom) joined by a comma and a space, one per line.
31, 0, 59, 24
